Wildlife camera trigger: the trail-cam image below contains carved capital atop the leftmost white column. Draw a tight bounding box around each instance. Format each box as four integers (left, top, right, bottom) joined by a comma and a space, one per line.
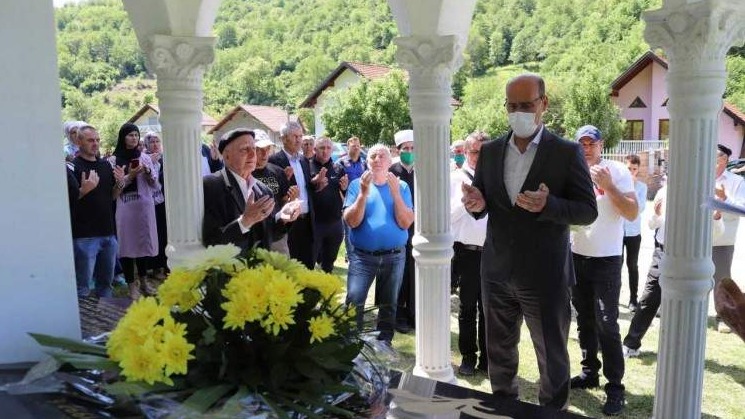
143, 35, 216, 86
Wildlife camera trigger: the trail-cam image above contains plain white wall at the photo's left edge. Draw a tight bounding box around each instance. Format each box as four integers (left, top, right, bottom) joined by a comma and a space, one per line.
0, 0, 80, 364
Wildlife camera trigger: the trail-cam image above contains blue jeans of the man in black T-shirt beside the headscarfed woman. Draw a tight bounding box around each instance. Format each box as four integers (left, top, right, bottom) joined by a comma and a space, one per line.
72, 236, 119, 297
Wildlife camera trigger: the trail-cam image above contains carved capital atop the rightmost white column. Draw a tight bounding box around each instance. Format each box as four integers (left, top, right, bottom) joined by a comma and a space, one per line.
644, 0, 745, 72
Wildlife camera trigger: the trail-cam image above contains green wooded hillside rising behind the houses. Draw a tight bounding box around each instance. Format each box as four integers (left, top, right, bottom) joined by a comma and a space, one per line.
56, 0, 745, 147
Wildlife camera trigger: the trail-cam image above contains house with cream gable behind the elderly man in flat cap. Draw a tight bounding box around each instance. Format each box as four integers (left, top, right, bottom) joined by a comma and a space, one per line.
207, 105, 297, 146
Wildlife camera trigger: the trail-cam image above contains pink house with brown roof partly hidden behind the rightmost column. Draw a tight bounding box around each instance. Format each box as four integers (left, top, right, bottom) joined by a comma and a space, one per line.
611, 51, 745, 157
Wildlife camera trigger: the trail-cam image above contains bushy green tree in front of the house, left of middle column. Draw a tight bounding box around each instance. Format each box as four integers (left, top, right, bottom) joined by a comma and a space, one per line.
321, 70, 412, 146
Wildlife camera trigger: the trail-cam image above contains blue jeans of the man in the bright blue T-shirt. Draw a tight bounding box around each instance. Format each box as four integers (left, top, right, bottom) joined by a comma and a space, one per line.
347, 246, 406, 342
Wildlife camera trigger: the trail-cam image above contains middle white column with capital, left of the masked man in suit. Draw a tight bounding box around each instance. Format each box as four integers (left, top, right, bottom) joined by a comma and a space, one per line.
395, 35, 462, 382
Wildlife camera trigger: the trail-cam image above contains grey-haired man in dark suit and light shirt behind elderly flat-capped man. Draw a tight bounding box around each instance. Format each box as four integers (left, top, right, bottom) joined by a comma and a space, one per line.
269, 121, 316, 269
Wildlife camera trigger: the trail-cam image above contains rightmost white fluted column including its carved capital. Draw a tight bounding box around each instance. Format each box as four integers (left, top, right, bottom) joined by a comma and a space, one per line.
644, 0, 745, 419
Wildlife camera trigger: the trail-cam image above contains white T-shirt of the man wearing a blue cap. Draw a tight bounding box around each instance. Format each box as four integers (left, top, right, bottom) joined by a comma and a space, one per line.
572, 159, 634, 257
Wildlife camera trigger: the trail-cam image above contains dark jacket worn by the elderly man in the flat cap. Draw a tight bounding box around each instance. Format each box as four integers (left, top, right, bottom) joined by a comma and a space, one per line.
202, 169, 283, 250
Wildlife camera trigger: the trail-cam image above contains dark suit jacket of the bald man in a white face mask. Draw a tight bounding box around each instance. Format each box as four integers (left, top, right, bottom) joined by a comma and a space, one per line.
473, 128, 598, 290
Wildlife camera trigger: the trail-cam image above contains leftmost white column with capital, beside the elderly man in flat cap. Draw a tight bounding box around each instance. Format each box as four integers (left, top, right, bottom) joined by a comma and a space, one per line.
143, 35, 215, 265
